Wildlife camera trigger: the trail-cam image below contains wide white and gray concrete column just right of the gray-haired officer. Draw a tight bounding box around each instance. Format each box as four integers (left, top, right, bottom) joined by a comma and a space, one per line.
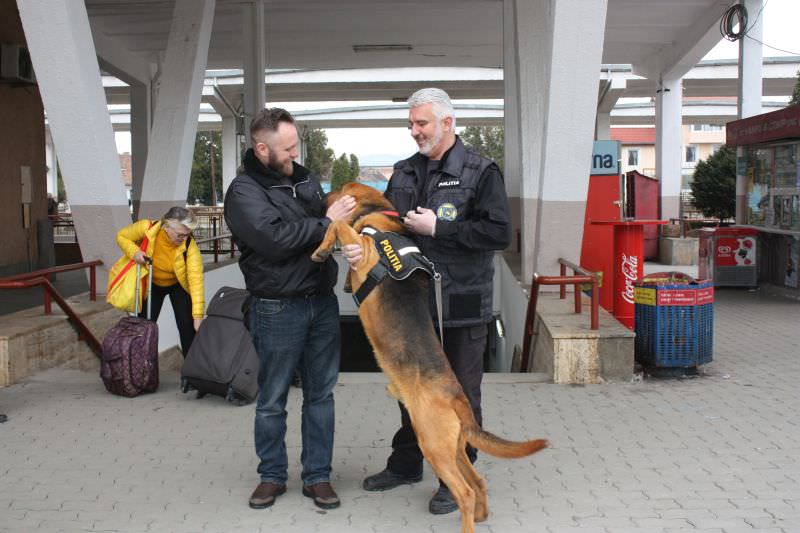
515, 0, 607, 282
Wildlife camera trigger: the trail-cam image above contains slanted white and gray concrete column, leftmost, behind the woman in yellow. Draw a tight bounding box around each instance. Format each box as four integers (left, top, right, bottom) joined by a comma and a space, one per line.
17, 0, 131, 282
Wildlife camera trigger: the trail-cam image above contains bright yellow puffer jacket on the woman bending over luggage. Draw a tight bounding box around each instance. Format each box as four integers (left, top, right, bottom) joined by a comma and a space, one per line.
117, 219, 206, 318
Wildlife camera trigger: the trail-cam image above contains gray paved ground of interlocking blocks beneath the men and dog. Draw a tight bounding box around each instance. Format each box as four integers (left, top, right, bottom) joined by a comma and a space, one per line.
0, 289, 800, 533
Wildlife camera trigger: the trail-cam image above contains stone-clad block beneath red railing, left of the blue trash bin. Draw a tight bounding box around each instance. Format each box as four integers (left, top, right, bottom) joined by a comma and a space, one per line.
532, 293, 635, 384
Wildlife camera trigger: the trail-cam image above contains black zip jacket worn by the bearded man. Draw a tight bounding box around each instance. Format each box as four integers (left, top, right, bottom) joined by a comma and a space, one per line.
225, 149, 337, 299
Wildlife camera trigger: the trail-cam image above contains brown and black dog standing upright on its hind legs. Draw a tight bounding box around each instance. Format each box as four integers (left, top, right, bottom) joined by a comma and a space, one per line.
312, 183, 548, 533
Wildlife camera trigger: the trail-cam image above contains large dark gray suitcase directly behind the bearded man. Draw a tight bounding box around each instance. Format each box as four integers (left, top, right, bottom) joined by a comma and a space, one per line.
181, 287, 258, 405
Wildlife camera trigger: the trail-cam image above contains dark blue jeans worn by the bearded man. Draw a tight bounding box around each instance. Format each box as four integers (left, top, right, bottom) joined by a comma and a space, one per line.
250, 294, 341, 485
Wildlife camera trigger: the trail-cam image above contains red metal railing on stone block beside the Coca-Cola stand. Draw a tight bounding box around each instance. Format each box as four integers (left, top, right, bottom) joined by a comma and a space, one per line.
520, 258, 600, 372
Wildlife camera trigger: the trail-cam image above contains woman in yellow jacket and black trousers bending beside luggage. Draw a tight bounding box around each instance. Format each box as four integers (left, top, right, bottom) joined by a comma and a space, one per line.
117, 206, 206, 357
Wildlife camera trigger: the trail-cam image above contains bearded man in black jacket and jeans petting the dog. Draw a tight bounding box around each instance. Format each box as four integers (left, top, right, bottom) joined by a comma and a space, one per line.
225, 108, 355, 509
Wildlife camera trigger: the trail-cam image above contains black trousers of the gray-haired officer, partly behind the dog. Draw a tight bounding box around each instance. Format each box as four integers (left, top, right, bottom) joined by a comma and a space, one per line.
386, 324, 487, 476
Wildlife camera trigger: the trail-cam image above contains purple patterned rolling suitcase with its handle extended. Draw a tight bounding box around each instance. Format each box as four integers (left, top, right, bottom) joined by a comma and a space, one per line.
100, 263, 158, 398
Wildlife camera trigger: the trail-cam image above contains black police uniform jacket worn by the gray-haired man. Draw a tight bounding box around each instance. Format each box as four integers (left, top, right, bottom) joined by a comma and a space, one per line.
385, 137, 511, 327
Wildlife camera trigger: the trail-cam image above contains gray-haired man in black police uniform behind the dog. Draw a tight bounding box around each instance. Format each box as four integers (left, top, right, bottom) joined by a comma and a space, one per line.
343, 88, 511, 514
